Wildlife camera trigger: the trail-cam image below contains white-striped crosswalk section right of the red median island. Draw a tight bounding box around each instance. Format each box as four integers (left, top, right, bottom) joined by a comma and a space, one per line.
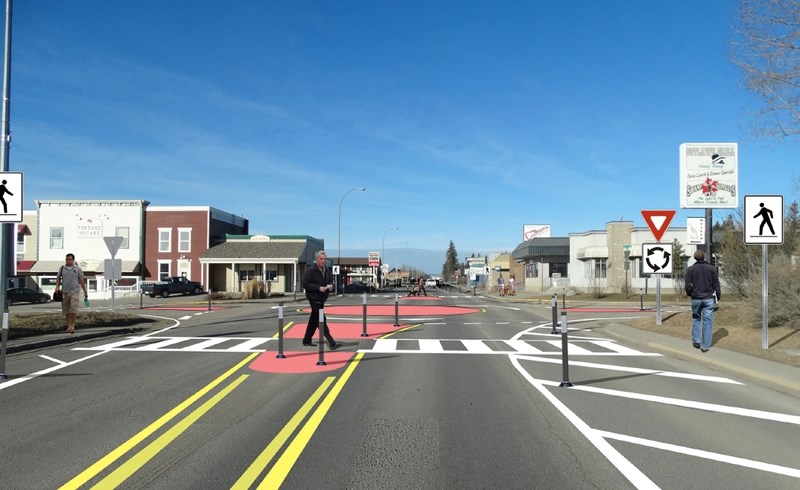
359, 339, 659, 356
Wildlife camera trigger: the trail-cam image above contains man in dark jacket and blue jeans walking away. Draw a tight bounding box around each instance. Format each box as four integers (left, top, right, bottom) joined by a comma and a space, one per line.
684, 250, 722, 352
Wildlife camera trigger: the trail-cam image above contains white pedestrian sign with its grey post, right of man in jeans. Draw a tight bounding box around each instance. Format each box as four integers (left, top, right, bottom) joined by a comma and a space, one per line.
743, 195, 783, 349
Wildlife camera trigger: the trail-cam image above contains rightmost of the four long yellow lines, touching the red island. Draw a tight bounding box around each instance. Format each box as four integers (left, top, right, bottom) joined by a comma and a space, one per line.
258, 352, 364, 489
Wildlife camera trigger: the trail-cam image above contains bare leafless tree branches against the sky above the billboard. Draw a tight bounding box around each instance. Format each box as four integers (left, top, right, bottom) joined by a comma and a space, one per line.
730, 0, 800, 137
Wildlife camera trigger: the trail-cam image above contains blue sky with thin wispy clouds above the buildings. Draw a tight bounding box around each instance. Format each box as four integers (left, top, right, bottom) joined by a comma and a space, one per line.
9, 0, 798, 272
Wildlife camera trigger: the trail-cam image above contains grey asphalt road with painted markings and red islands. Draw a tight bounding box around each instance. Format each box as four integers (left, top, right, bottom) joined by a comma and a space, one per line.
0, 293, 800, 489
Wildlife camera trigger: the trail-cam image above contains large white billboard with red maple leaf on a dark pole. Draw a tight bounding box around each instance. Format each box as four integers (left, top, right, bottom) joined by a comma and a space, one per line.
680, 143, 739, 208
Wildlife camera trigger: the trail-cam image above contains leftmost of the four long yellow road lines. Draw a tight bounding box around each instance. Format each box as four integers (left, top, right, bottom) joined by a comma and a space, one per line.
59, 352, 259, 490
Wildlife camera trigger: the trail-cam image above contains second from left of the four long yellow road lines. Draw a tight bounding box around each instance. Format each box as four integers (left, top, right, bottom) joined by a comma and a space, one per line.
92, 374, 250, 489
